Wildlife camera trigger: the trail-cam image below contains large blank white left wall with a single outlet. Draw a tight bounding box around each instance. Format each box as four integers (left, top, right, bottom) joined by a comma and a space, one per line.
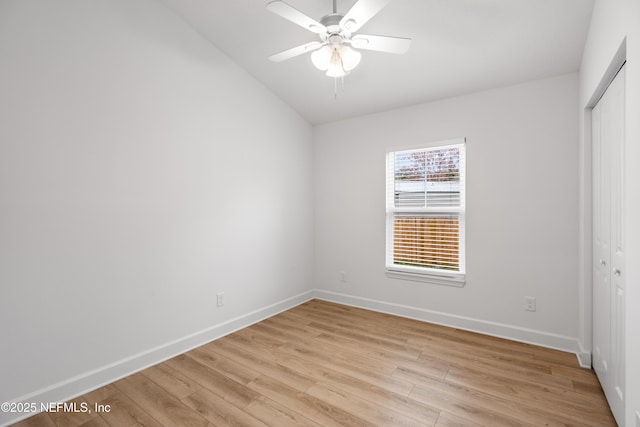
0, 0, 313, 424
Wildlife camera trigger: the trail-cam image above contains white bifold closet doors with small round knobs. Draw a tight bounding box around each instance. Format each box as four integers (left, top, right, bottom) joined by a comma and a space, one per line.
592, 62, 625, 425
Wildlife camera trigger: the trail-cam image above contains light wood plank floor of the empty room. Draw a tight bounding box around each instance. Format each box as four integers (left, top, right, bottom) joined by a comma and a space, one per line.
17, 300, 615, 427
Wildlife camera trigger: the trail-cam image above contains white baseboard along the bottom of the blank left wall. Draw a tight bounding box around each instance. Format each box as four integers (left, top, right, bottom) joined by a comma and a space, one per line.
0, 291, 315, 427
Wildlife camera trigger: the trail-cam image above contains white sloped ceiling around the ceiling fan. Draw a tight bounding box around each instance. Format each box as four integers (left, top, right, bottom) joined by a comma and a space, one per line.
161, 0, 593, 124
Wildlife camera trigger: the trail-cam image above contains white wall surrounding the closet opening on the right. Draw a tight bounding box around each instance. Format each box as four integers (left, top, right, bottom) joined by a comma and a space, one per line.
580, 0, 640, 427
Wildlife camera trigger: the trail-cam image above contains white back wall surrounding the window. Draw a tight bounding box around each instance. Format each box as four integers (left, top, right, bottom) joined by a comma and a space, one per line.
314, 74, 578, 351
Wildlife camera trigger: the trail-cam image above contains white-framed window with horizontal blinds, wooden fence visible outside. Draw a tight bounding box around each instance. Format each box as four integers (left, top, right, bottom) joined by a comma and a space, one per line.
386, 140, 465, 286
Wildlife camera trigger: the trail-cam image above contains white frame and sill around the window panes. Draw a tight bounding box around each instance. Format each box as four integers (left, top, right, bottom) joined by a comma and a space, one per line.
385, 138, 466, 287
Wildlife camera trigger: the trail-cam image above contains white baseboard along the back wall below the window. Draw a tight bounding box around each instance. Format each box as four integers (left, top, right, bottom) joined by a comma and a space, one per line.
315, 289, 591, 366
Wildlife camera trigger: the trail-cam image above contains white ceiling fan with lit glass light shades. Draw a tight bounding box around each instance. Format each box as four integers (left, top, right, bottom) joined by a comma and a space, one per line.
267, 0, 411, 78
